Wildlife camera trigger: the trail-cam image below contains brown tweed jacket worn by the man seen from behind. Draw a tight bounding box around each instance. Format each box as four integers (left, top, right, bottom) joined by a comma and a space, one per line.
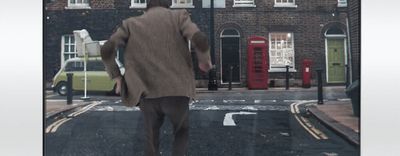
101, 7, 210, 107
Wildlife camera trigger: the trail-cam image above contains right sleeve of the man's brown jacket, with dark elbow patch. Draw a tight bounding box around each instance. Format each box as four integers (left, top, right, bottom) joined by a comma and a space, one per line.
179, 10, 210, 63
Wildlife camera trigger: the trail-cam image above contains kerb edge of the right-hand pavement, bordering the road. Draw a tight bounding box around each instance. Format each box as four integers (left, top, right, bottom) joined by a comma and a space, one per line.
308, 107, 360, 146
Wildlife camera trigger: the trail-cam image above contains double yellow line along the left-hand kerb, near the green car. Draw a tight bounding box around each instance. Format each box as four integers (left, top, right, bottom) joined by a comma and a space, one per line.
46, 102, 101, 133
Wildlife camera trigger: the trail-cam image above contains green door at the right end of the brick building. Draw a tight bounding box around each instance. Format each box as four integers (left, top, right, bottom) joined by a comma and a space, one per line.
327, 39, 345, 83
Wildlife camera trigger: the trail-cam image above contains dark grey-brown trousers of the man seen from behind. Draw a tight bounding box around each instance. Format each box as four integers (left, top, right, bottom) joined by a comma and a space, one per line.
140, 96, 190, 156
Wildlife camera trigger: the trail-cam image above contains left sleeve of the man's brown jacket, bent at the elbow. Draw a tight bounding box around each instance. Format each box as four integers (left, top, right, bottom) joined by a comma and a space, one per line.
101, 21, 129, 79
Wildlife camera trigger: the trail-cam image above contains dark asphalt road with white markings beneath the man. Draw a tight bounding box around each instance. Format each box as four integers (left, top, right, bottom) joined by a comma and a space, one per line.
45, 89, 359, 156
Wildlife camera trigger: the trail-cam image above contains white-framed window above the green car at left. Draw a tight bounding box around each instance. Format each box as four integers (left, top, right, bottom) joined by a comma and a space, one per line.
61, 35, 78, 64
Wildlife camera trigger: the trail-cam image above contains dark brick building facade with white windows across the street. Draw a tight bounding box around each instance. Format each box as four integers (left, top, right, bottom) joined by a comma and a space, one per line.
45, 0, 357, 87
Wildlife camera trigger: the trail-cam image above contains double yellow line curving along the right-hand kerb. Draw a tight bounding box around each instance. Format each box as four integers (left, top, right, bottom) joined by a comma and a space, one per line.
290, 101, 328, 140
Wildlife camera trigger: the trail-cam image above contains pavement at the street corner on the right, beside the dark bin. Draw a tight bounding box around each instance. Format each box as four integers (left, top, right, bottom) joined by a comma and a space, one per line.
308, 101, 360, 146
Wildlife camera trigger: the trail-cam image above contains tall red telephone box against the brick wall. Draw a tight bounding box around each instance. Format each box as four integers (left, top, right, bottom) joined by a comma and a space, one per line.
247, 36, 268, 89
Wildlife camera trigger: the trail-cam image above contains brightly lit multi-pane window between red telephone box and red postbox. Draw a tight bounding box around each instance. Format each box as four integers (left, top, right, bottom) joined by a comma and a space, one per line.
269, 32, 294, 71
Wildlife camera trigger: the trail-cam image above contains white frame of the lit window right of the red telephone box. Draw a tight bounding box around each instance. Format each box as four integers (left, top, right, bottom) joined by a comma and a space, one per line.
268, 31, 297, 72
